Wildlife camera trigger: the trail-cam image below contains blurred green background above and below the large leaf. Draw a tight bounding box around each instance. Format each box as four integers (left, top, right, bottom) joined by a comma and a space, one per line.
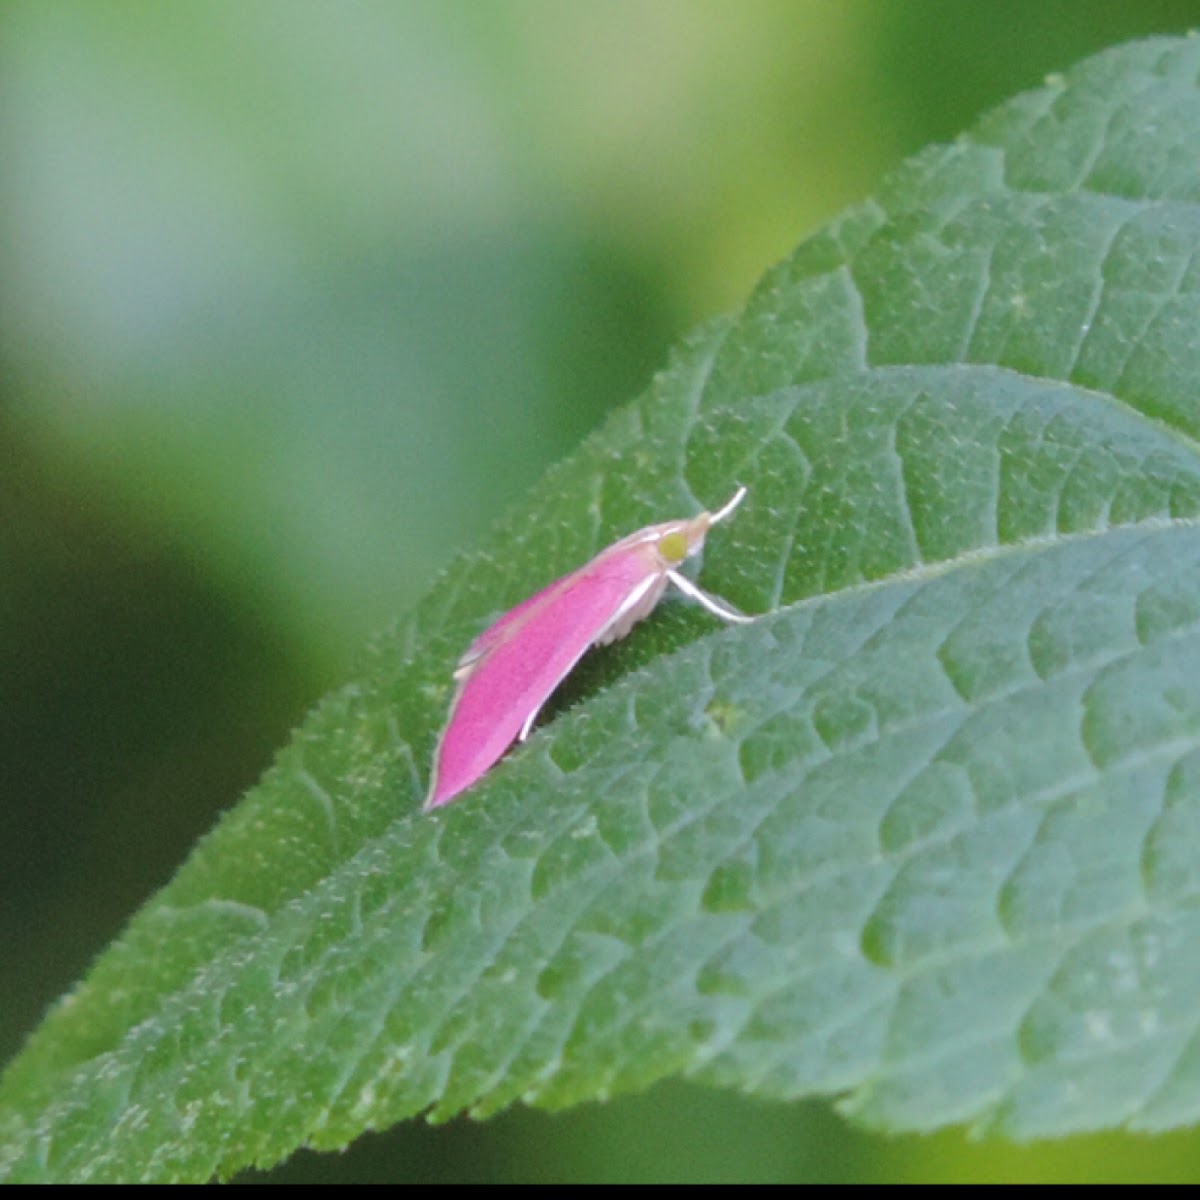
7, 0, 1200, 1181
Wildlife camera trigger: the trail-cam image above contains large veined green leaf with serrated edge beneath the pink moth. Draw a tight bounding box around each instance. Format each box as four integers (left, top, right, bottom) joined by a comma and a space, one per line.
0, 40, 1200, 1180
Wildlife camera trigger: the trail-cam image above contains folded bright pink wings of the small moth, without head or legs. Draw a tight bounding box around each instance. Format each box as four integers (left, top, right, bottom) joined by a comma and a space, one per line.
425, 539, 661, 809
